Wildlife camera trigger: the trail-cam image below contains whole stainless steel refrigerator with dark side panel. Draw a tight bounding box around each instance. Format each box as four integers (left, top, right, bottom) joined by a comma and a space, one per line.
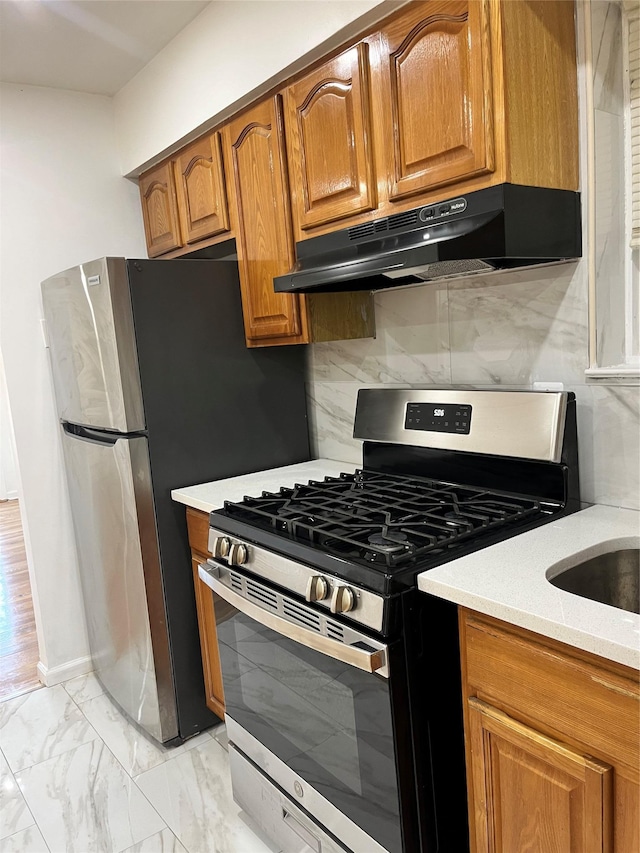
42, 258, 309, 743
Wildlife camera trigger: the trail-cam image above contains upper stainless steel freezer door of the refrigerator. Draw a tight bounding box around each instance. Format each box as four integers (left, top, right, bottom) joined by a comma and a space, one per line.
42, 258, 145, 432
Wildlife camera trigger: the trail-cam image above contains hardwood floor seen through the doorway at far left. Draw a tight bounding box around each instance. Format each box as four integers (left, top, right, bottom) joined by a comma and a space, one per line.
0, 501, 42, 700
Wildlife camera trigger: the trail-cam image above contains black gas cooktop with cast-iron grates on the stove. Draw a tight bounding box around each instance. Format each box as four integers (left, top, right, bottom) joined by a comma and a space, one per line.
211, 469, 559, 588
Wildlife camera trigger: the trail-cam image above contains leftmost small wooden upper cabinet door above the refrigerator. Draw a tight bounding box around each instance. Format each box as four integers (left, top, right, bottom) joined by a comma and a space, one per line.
139, 162, 182, 258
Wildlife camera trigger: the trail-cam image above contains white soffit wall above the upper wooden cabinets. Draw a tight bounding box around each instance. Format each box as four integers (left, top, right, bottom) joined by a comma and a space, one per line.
114, 0, 392, 175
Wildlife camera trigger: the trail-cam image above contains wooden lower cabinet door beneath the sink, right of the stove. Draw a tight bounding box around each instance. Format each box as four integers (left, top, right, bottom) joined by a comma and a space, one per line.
468, 698, 613, 853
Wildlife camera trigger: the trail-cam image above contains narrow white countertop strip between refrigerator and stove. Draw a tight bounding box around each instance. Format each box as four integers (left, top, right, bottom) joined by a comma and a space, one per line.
171, 459, 357, 512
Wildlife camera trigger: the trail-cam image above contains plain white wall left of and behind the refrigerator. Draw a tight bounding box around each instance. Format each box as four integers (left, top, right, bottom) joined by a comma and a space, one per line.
0, 84, 146, 681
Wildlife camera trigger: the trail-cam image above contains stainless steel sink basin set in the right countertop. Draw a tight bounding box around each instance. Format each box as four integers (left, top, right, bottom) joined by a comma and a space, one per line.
547, 548, 640, 613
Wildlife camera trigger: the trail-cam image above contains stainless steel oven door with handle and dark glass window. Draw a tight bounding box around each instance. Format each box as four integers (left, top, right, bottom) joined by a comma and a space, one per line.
200, 561, 402, 853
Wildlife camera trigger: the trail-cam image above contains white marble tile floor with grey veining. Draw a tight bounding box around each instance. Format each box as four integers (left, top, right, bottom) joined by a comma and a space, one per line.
0, 675, 278, 853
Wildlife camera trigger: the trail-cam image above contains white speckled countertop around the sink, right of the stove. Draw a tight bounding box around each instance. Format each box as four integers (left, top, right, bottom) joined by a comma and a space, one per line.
418, 505, 640, 669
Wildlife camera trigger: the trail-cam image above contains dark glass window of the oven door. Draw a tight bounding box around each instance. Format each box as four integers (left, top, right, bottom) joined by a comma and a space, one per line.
216, 596, 401, 851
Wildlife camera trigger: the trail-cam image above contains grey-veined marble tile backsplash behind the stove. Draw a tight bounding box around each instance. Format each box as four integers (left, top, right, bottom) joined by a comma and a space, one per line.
307, 260, 640, 509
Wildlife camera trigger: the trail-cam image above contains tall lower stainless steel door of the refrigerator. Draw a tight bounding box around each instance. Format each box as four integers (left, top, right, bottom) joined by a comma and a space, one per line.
63, 425, 178, 742
